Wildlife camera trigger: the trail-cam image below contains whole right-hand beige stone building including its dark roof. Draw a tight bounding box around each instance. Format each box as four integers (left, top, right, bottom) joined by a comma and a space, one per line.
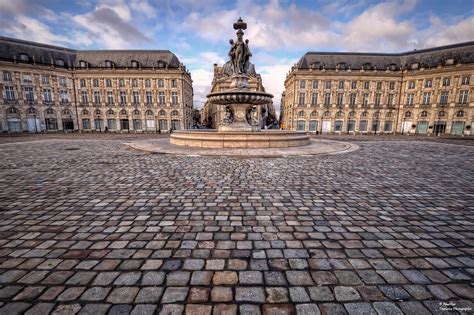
281, 42, 474, 135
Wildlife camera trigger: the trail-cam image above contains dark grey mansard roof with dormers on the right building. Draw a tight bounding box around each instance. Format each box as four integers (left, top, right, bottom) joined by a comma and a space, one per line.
296, 42, 474, 70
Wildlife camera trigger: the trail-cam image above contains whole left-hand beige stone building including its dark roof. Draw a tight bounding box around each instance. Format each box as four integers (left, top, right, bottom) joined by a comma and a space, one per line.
0, 37, 193, 132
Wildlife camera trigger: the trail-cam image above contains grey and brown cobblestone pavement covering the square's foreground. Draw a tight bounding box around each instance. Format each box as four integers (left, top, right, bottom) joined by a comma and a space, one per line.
0, 139, 474, 315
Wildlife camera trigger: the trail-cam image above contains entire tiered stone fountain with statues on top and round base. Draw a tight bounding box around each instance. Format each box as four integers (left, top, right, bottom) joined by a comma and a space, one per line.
170, 18, 310, 148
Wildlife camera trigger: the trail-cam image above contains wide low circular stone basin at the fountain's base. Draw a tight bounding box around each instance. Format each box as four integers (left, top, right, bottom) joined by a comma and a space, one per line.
170, 130, 310, 148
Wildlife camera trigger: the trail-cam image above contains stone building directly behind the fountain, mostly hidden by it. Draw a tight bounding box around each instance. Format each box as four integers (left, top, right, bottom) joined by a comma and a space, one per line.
200, 64, 276, 129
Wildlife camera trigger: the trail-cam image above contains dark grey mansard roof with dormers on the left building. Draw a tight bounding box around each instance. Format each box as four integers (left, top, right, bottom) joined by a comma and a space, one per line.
0, 36, 180, 68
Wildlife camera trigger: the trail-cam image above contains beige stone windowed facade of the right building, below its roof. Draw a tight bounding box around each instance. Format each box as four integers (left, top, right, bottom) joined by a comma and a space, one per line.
281, 48, 474, 135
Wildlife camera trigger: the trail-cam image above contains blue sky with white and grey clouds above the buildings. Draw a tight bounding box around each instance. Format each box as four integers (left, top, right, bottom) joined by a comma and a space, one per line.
0, 0, 474, 112
